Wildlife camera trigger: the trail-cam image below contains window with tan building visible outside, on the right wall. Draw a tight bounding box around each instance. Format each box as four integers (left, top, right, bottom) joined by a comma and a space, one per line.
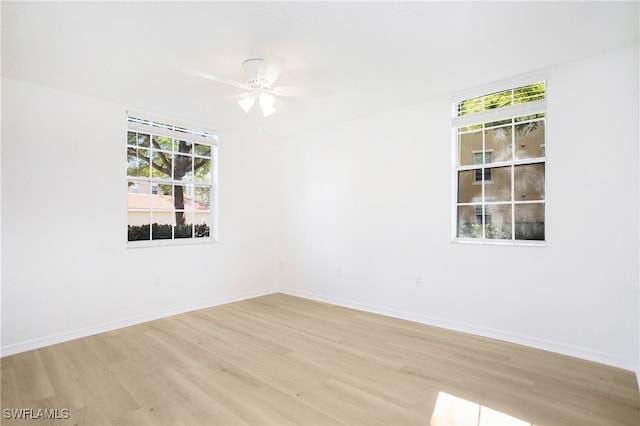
453, 82, 546, 243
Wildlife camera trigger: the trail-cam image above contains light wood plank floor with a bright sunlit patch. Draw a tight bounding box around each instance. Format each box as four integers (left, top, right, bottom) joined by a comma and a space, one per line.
1, 294, 640, 426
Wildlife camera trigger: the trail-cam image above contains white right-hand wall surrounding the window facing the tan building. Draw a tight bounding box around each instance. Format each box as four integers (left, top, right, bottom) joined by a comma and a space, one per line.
280, 45, 639, 370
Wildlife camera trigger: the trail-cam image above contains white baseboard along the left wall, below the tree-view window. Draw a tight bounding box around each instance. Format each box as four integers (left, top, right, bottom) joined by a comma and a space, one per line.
0, 288, 279, 357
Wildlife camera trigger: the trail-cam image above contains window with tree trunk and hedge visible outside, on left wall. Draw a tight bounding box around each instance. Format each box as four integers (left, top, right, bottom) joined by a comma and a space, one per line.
127, 116, 217, 246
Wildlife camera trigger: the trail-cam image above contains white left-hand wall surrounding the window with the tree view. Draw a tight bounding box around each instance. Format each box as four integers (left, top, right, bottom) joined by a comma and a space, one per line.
2, 79, 278, 355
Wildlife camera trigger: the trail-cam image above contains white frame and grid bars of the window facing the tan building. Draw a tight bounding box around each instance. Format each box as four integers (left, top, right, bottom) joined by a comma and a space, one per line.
451, 80, 548, 246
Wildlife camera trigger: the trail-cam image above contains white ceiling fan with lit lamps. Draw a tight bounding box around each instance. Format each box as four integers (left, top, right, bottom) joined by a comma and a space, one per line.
192, 56, 333, 117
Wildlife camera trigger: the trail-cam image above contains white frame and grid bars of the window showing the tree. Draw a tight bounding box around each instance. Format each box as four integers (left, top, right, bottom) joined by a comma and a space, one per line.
125, 111, 218, 248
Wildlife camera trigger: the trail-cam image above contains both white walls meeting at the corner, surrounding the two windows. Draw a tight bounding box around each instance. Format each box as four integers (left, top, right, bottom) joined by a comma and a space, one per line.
2, 45, 640, 376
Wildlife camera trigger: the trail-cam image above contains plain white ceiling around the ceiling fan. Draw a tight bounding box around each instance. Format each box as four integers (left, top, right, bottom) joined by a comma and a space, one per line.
1, 1, 639, 136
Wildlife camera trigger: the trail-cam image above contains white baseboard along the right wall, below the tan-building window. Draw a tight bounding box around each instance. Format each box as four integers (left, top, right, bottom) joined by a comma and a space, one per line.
280, 288, 640, 374
